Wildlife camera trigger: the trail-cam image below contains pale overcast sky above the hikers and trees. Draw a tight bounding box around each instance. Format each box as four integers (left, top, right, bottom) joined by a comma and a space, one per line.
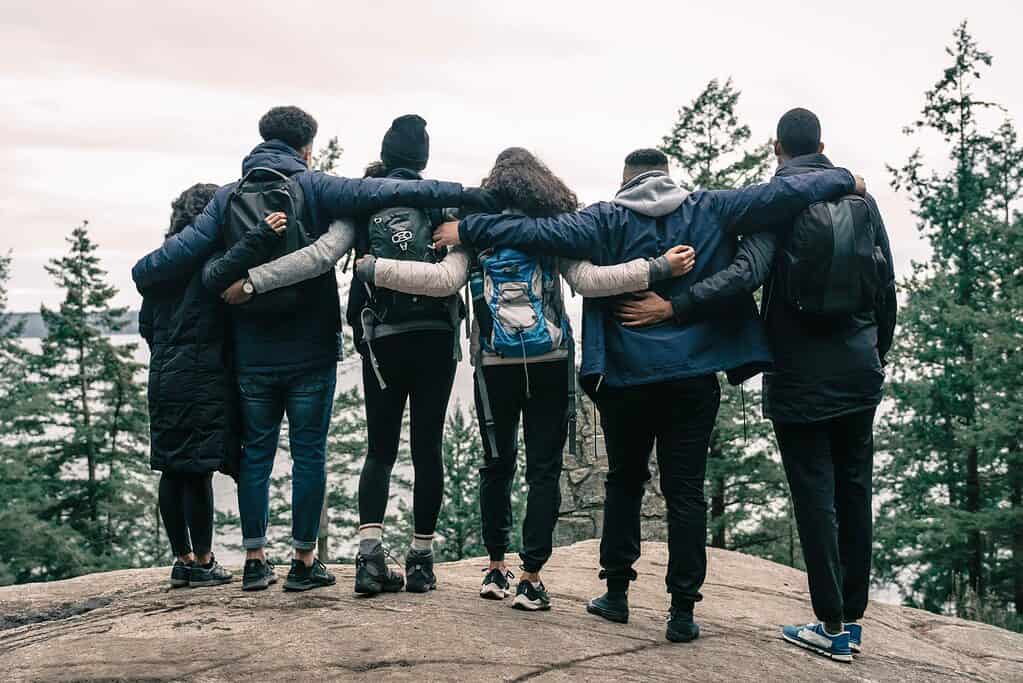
0, 0, 1023, 311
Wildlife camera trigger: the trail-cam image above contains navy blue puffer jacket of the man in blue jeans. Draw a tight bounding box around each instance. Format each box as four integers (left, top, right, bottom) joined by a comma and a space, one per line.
132, 140, 462, 372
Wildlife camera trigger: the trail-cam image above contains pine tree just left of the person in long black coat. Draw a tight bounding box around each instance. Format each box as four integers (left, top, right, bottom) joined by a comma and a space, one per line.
34, 222, 153, 567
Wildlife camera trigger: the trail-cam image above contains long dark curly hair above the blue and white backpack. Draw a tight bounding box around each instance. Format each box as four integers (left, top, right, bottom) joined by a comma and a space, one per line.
481, 147, 579, 216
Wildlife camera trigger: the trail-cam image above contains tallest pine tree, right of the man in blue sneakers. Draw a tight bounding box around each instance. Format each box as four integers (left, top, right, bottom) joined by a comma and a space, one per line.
876, 22, 1023, 617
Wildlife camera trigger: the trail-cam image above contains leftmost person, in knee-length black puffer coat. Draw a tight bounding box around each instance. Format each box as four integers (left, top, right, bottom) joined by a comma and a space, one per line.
139, 184, 284, 587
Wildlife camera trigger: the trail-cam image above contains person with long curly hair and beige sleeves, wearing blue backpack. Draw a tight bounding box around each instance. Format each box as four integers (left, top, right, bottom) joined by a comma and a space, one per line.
356, 147, 693, 610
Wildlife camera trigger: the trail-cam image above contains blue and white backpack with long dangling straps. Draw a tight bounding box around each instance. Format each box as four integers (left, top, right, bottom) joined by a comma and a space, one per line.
469, 248, 576, 457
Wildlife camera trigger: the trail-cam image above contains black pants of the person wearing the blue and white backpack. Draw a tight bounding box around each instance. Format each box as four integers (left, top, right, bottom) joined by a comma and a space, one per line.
476, 360, 569, 572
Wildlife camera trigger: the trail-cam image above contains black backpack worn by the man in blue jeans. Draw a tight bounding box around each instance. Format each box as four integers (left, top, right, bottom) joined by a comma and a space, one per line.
224, 167, 314, 313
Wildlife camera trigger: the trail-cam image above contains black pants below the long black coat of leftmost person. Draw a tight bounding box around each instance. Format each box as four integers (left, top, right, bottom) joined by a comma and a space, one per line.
159, 472, 213, 557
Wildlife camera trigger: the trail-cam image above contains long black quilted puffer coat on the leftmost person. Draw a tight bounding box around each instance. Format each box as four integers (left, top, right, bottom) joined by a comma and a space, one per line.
139, 271, 241, 477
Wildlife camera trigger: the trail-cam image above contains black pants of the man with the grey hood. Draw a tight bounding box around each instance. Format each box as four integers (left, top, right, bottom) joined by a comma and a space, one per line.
594, 374, 721, 602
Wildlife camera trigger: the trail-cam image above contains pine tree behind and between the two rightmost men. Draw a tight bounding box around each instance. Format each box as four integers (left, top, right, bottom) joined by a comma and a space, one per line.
660, 79, 798, 561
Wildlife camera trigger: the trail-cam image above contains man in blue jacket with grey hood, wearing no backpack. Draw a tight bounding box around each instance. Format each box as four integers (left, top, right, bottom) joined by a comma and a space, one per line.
435, 150, 864, 642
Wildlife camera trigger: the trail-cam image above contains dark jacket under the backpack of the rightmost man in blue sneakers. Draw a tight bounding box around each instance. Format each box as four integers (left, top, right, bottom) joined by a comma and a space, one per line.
763, 154, 897, 422
